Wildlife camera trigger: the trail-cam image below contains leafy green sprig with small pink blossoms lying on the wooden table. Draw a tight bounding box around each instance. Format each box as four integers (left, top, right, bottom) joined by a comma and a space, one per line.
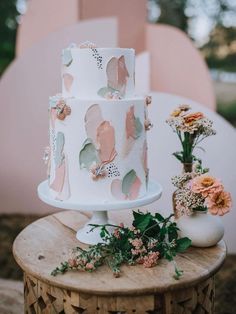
51, 211, 191, 279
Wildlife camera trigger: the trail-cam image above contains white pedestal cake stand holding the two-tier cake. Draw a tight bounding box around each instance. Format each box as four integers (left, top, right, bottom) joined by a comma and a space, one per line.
38, 180, 162, 244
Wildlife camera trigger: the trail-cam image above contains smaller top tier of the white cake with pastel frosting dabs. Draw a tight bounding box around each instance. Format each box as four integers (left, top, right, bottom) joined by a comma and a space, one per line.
62, 44, 135, 99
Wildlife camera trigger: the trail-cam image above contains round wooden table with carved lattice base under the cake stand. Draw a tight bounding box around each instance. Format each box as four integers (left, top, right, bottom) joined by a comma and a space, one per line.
13, 211, 226, 314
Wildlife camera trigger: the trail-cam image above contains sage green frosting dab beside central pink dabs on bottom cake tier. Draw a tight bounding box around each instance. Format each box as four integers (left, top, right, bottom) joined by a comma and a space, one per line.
79, 139, 99, 170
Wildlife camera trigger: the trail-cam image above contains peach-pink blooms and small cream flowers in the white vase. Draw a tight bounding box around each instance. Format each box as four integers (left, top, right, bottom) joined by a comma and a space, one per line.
172, 162, 232, 218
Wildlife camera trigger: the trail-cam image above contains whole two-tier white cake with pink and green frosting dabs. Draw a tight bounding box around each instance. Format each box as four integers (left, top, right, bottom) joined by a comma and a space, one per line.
46, 44, 150, 202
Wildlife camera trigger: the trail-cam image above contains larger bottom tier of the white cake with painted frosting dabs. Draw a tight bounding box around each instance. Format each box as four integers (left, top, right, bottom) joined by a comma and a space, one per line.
48, 96, 148, 202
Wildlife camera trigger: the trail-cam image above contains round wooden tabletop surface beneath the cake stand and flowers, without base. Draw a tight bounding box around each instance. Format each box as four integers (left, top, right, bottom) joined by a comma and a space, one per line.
13, 211, 226, 296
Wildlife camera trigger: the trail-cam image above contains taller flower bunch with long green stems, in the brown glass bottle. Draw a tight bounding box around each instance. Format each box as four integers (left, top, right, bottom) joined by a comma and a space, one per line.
166, 105, 216, 164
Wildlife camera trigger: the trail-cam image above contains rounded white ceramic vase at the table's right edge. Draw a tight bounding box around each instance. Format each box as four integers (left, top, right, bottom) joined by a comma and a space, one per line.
176, 211, 224, 247
